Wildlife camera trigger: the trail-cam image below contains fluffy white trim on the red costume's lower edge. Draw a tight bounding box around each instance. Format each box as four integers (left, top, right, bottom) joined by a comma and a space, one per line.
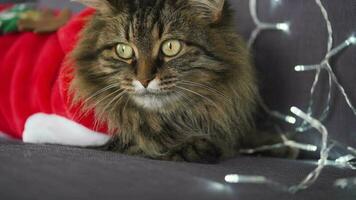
23, 113, 110, 147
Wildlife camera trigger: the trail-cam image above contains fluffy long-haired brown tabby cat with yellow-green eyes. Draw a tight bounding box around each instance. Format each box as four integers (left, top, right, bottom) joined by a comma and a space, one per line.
70, 0, 294, 163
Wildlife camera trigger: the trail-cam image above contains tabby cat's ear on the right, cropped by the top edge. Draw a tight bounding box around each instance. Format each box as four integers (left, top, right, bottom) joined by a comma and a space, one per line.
189, 0, 225, 23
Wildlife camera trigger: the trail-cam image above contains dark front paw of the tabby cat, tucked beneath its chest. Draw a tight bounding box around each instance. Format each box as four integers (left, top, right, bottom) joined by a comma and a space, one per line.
163, 136, 222, 163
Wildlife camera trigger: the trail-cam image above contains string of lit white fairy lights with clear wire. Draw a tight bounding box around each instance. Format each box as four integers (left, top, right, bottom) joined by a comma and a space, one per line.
225, 0, 356, 193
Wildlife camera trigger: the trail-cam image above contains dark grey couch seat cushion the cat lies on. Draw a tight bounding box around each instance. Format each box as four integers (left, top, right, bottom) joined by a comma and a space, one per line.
0, 140, 356, 200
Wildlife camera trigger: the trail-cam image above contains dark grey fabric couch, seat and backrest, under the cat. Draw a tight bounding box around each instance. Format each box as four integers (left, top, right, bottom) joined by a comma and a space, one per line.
0, 0, 356, 200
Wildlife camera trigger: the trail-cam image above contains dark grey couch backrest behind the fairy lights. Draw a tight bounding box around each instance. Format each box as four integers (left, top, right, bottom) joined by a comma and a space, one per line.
230, 0, 356, 151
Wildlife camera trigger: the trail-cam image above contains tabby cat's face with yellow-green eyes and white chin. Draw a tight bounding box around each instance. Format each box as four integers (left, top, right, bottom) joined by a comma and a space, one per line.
74, 0, 239, 110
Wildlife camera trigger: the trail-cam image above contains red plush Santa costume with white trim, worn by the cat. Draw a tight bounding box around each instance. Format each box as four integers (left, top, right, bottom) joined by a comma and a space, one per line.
0, 7, 109, 146
